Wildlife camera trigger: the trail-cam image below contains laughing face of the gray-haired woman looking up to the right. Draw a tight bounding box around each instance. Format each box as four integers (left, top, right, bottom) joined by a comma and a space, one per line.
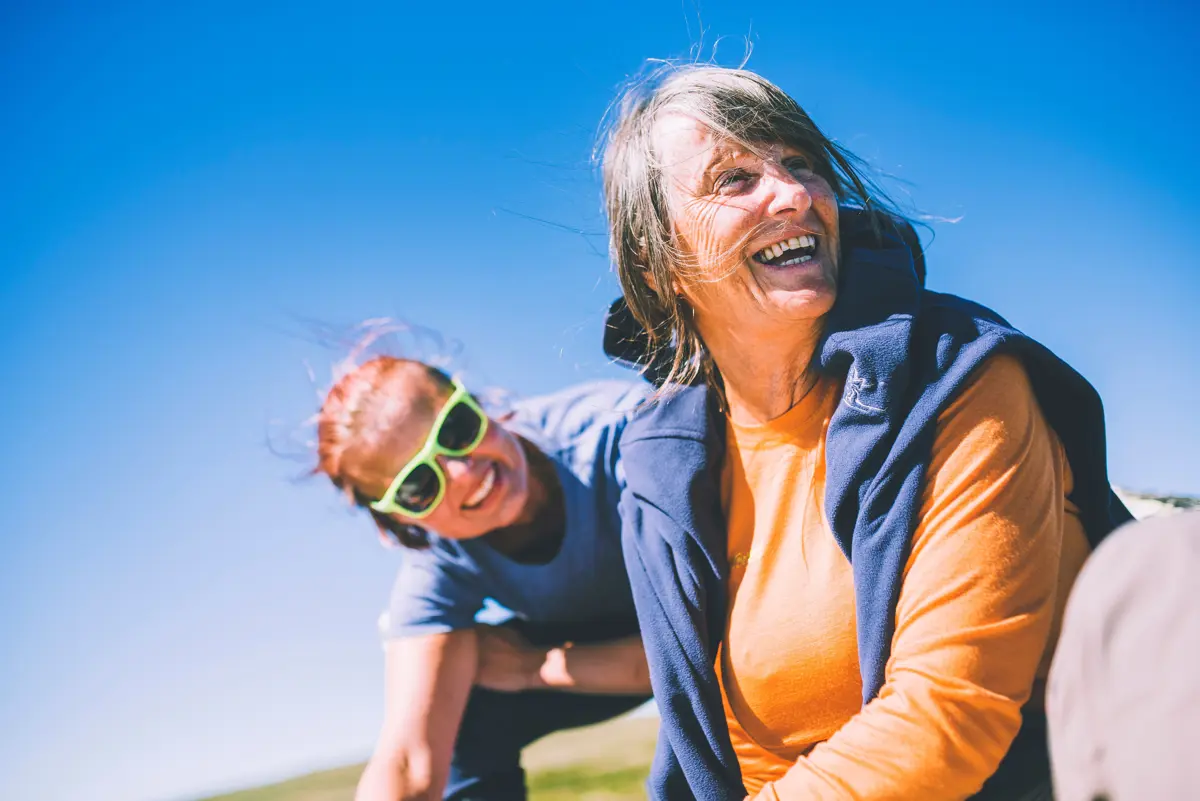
655, 114, 839, 339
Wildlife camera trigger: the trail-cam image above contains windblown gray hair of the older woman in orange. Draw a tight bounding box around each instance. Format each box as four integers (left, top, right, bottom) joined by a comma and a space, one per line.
601, 64, 900, 392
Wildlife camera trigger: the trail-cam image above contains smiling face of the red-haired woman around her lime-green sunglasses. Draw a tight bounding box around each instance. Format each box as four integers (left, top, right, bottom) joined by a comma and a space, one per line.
358, 380, 529, 540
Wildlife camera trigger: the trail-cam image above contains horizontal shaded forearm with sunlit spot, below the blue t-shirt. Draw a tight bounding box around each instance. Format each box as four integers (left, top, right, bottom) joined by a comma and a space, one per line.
475, 627, 650, 695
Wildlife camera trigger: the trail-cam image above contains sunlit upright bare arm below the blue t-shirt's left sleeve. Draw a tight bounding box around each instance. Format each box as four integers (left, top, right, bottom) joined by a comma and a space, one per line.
354, 630, 478, 801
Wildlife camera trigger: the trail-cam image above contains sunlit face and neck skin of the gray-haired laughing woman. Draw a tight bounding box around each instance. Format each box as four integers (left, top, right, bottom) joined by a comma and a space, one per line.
655, 114, 840, 422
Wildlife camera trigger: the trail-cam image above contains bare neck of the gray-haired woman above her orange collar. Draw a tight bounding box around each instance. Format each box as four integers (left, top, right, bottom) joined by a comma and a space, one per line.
701, 323, 821, 424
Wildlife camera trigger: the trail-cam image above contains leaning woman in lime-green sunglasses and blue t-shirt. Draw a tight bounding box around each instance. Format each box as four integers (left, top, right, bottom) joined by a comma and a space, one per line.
317, 357, 649, 801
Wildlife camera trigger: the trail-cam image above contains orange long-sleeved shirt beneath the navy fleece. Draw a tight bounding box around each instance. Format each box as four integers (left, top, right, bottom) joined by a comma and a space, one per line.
718, 356, 1088, 801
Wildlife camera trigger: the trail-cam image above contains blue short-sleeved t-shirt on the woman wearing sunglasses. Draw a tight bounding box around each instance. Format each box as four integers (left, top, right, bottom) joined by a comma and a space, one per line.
383, 381, 652, 639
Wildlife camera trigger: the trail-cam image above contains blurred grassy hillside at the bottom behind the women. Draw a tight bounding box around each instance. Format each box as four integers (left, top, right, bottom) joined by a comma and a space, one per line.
204, 717, 659, 801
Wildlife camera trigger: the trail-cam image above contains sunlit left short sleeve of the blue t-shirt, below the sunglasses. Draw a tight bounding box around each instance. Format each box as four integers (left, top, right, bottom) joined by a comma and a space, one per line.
380, 542, 485, 640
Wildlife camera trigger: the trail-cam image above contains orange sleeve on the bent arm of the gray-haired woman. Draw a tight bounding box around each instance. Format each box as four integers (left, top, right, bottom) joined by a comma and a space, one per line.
757, 356, 1067, 801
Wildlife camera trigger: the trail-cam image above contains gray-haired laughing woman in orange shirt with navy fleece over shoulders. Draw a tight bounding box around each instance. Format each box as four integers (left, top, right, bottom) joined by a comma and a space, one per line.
604, 66, 1128, 801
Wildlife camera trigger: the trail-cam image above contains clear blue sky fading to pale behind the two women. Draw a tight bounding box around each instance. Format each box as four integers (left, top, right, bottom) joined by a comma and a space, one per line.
0, 0, 1200, 801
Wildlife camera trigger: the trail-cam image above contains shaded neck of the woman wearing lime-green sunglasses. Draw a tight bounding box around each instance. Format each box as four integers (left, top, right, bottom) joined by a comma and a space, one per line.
485, 436, 566, 565
